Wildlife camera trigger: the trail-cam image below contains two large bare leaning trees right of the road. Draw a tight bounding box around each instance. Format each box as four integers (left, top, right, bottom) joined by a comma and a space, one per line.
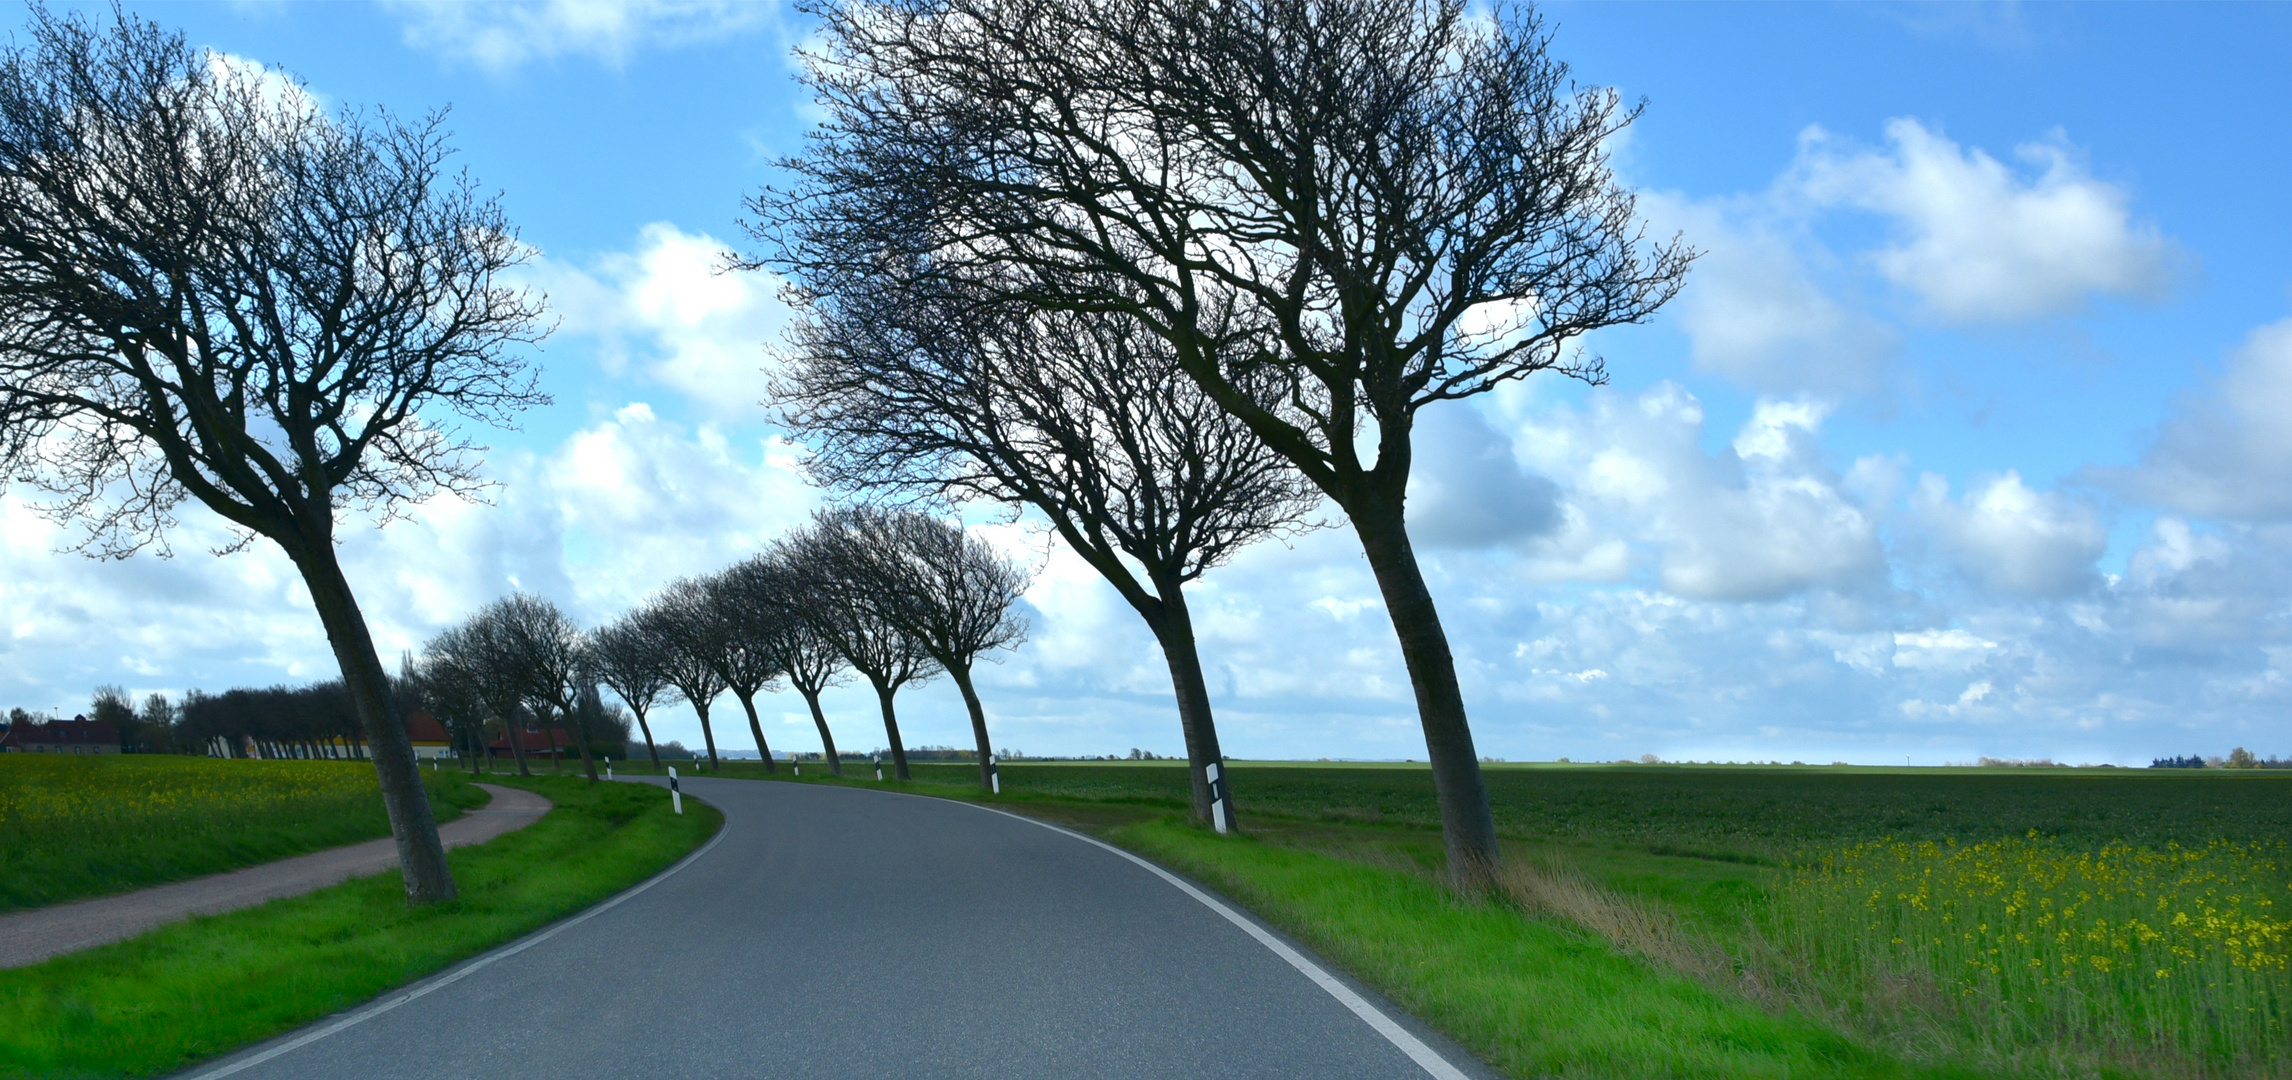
749, 0, 1691, 887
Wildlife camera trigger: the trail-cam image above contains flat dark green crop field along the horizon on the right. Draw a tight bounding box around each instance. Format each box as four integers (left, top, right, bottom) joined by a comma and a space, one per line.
669, 761, 2292, 862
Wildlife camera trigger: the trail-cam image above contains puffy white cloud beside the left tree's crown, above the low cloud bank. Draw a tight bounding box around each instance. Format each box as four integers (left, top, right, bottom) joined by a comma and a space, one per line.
527, 222, 788, 422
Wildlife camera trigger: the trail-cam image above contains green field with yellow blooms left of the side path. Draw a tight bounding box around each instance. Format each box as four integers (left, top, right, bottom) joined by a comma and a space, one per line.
0, 754, 486, 913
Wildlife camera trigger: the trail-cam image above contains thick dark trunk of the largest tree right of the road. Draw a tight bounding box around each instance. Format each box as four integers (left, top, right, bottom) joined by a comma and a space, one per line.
1345, 502, 1497, 892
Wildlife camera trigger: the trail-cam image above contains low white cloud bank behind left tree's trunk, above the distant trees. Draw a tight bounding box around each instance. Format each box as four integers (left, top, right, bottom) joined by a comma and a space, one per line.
0, 404, 814, 709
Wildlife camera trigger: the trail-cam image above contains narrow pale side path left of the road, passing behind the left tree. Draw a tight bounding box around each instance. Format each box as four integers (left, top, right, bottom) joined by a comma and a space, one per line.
0, 784, 550, 968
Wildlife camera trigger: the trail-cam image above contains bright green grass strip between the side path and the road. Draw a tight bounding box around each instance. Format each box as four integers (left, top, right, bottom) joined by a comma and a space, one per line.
0, 775, 722, 1078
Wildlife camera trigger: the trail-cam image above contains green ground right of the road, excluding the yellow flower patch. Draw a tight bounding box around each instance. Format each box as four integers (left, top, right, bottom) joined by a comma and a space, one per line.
696, 761, 2292, 1078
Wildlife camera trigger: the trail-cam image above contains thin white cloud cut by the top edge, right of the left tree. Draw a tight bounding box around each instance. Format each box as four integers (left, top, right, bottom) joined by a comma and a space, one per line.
385, 0, 777, 71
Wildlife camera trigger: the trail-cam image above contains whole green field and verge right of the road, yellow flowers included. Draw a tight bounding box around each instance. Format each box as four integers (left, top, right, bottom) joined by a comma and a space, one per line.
687, 761, 2292, 1078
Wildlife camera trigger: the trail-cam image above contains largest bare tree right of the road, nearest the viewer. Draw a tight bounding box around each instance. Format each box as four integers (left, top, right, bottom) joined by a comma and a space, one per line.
752, 0, 1691, 887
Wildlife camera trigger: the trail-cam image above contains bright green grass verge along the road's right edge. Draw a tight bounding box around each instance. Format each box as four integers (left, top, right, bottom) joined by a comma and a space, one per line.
1109, 821, 1980, 1080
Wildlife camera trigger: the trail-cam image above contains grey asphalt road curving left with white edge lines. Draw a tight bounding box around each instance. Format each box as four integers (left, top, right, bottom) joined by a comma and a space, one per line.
186, 780, 1490, 1080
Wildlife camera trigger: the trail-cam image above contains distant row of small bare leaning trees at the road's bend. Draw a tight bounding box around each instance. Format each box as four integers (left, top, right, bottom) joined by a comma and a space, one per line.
410, 507, 1027, 786
